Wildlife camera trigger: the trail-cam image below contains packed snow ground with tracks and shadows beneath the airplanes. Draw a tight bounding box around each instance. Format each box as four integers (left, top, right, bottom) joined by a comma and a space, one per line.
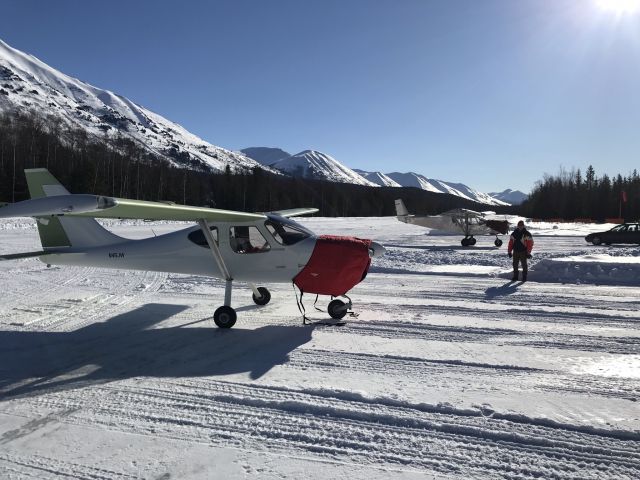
0, 218, 640, 479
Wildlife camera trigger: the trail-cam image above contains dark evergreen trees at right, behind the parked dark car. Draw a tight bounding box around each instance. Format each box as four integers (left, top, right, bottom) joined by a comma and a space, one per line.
521, 165, 640, 221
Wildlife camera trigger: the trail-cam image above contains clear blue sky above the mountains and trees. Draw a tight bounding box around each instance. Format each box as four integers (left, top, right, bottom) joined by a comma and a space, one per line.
0, 0, 640, 191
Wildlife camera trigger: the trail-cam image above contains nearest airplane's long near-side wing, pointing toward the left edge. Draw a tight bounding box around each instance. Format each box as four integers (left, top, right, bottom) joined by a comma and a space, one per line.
0, 194, 266, 222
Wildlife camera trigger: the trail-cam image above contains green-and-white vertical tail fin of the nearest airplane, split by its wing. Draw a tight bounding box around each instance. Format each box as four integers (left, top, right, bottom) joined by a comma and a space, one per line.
24, 168, 124, 250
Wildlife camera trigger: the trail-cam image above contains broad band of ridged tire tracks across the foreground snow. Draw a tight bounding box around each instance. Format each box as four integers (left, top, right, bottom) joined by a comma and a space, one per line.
8, 379, 640, 479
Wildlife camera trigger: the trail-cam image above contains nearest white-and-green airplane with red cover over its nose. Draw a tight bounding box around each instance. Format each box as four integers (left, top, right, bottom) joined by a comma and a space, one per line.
0, 168, 385, 328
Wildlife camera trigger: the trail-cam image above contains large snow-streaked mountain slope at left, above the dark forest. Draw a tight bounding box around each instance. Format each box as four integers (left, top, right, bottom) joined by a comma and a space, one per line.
0, 40, 260, 172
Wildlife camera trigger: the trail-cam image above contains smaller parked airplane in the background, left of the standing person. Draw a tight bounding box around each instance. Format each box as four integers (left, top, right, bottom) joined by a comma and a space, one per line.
396, 199, 509, 247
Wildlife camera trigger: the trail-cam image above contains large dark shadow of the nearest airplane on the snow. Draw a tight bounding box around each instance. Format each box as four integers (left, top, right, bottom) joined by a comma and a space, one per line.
0, 304, 313, 399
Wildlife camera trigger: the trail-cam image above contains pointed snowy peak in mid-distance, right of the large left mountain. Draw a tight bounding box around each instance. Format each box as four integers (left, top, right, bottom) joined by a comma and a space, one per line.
271, 150, 377, 187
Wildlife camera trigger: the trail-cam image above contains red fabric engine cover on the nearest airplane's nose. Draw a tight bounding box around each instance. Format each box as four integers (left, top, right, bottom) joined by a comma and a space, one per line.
293, 235, 371, 297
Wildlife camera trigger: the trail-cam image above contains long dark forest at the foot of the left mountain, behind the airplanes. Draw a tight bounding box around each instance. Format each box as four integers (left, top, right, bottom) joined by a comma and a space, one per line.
0, 111, 504, 216
